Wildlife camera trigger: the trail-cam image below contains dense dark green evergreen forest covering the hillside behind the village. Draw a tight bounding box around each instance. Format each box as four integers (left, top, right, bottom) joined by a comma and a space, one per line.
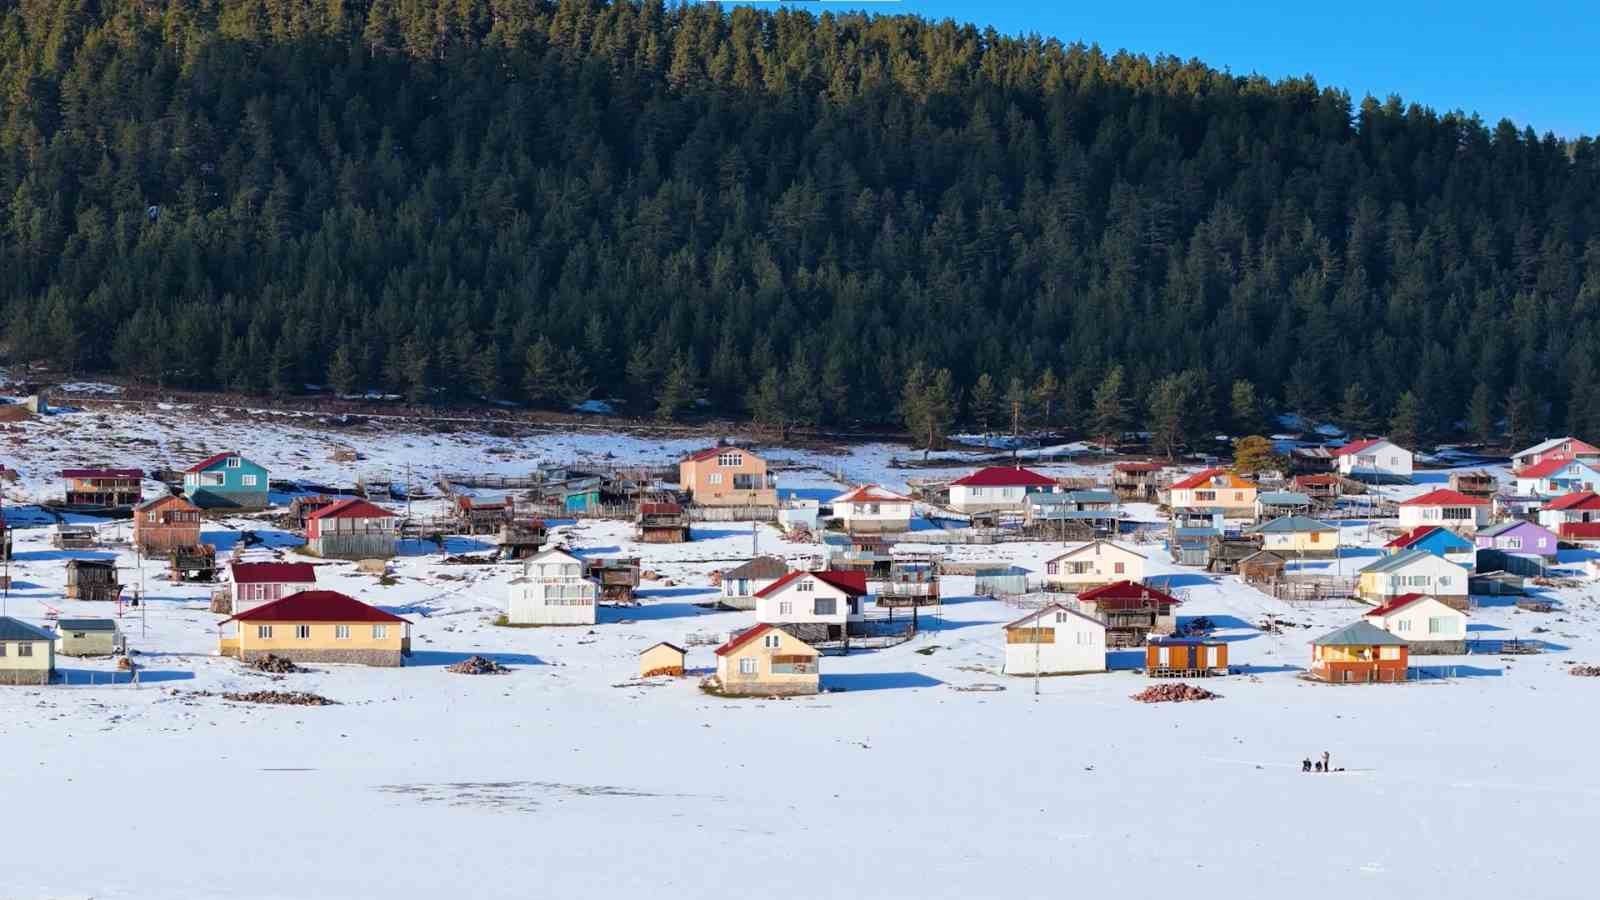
0, 0, 1600, 444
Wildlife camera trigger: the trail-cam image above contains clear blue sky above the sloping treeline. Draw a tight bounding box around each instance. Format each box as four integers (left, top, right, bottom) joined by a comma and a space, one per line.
716, 0, 1600, 138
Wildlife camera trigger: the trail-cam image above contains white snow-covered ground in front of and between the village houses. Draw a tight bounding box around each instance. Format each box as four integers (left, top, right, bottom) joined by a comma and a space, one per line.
0, 400, 1600, 898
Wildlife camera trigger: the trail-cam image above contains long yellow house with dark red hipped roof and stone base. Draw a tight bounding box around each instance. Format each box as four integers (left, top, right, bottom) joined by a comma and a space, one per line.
218, 591, 411, 666
